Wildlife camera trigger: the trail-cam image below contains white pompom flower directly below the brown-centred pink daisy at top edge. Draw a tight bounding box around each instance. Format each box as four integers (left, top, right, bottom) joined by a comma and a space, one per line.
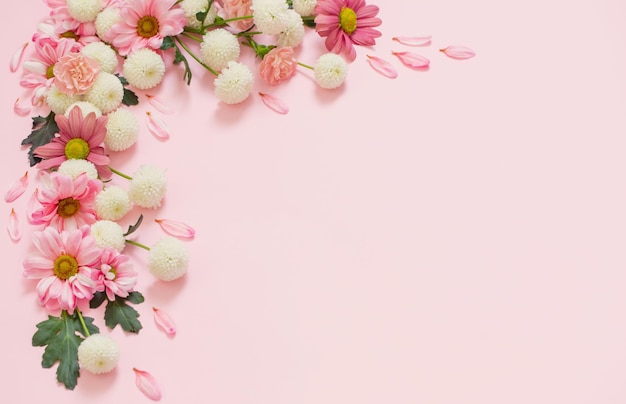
124, 48, 165, 90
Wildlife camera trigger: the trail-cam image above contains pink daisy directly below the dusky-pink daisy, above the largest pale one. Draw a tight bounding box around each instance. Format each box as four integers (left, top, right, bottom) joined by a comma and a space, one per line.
31, 171, 102, 231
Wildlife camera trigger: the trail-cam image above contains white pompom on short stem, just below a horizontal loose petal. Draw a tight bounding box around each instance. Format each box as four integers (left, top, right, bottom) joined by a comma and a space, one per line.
148, 236, 189, 281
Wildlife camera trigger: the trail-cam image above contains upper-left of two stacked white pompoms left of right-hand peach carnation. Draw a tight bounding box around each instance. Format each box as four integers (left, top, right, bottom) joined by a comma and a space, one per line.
200, 28, 241, 71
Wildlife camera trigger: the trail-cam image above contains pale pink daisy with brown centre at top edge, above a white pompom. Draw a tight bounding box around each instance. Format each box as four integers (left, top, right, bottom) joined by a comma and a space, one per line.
105, 0, 187, 56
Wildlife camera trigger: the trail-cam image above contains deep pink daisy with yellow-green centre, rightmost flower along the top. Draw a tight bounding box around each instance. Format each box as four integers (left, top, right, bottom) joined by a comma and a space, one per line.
315, 0, 382, 62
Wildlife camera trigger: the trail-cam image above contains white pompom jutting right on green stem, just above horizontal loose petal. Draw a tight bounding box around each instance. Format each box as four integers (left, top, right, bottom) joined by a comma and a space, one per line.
128, 164, 167, 209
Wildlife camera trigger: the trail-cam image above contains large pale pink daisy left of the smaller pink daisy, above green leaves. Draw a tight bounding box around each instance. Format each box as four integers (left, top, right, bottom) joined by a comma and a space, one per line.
23, 227, 101, 313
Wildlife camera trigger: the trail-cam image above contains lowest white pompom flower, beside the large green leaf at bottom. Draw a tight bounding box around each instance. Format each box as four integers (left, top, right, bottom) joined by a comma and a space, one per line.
78, 334, 120, 374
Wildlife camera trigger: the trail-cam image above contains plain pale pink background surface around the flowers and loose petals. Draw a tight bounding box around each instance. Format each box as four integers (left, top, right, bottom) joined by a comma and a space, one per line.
0, 0, 626, 404
